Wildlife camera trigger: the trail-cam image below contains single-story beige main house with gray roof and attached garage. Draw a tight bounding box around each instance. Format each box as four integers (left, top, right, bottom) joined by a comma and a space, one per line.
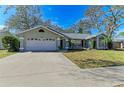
17, 26, 106, 51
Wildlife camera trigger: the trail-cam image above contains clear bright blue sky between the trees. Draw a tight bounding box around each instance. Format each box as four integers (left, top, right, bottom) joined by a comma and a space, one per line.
0, 5, 88, 28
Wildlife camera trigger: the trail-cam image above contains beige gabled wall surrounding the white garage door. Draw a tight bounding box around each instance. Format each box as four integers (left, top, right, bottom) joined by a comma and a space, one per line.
19, 28, 61, 51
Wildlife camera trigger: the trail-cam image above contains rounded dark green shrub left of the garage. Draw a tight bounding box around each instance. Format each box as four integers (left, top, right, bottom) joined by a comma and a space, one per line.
2, 36, 20, 52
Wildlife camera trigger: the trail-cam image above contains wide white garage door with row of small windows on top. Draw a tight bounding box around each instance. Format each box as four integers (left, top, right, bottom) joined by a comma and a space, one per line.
26, 38, 56, 51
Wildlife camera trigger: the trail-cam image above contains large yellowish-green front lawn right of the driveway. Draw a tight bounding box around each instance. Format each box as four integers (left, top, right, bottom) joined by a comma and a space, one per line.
64, 50, 124, 68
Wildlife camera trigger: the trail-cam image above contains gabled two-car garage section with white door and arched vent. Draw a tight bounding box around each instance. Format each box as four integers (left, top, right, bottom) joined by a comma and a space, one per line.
19, 27, 60, 51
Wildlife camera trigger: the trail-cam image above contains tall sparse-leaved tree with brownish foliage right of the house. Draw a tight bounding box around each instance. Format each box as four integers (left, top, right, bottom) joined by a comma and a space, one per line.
85, 6, 124, 49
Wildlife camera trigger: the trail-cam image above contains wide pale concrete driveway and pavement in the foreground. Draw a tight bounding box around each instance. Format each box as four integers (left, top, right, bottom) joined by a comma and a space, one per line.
0, 52, 124, 87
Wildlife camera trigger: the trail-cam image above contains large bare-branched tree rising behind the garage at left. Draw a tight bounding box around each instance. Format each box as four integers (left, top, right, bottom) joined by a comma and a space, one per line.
4, 5, 43, 31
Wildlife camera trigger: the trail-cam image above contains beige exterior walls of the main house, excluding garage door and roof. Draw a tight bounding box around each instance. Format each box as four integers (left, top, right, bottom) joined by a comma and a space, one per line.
19, 28, 111, 51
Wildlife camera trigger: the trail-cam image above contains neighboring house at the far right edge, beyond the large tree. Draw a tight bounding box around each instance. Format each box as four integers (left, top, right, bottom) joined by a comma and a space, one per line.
113, 35, 124, 49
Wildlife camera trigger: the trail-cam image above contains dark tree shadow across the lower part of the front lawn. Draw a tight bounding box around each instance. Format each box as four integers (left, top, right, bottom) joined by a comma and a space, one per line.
74, 59, 124, 68
